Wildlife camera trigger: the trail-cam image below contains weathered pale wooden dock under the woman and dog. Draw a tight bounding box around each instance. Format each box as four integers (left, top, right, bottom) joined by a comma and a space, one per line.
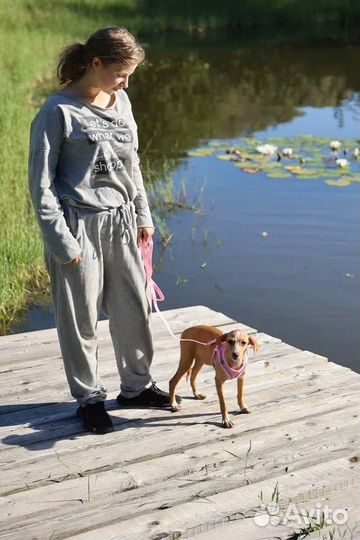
0, 306, 360, 540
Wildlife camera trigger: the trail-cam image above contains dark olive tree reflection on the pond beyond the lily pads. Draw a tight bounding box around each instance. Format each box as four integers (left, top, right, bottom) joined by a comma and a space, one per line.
129, 37, 360, 167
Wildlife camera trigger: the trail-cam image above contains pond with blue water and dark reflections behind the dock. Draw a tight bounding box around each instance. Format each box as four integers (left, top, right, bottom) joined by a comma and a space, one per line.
12, 30, 360, 371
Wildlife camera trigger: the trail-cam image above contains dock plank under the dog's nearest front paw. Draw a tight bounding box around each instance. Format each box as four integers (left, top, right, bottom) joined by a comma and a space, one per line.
0, 376, 359, 494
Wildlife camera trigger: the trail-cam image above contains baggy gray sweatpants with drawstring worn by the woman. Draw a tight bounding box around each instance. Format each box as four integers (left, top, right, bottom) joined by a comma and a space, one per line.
44, 202, 154, 405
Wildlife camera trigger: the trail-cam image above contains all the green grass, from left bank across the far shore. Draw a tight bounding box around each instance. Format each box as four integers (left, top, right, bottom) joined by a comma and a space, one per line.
0, 0, 359, 333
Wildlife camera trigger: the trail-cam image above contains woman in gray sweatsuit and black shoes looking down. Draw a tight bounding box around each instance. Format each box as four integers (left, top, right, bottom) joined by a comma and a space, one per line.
28, 26, 181, 433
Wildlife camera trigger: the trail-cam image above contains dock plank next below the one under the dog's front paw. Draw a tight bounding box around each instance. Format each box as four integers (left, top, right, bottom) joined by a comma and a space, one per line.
0, 407, 359, 528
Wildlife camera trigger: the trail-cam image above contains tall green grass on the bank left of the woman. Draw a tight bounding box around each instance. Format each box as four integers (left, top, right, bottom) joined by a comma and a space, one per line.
0, 0, 114, 333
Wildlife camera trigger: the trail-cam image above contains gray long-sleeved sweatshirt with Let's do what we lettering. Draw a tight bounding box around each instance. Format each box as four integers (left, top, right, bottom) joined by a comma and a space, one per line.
28, 90, 154, 263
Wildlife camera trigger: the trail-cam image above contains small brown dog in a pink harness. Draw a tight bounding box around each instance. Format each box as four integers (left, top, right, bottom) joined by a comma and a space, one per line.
169, 325, 259, 428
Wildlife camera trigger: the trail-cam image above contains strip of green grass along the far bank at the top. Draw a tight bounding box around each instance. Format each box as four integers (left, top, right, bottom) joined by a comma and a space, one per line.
14, 0, 360, 38
